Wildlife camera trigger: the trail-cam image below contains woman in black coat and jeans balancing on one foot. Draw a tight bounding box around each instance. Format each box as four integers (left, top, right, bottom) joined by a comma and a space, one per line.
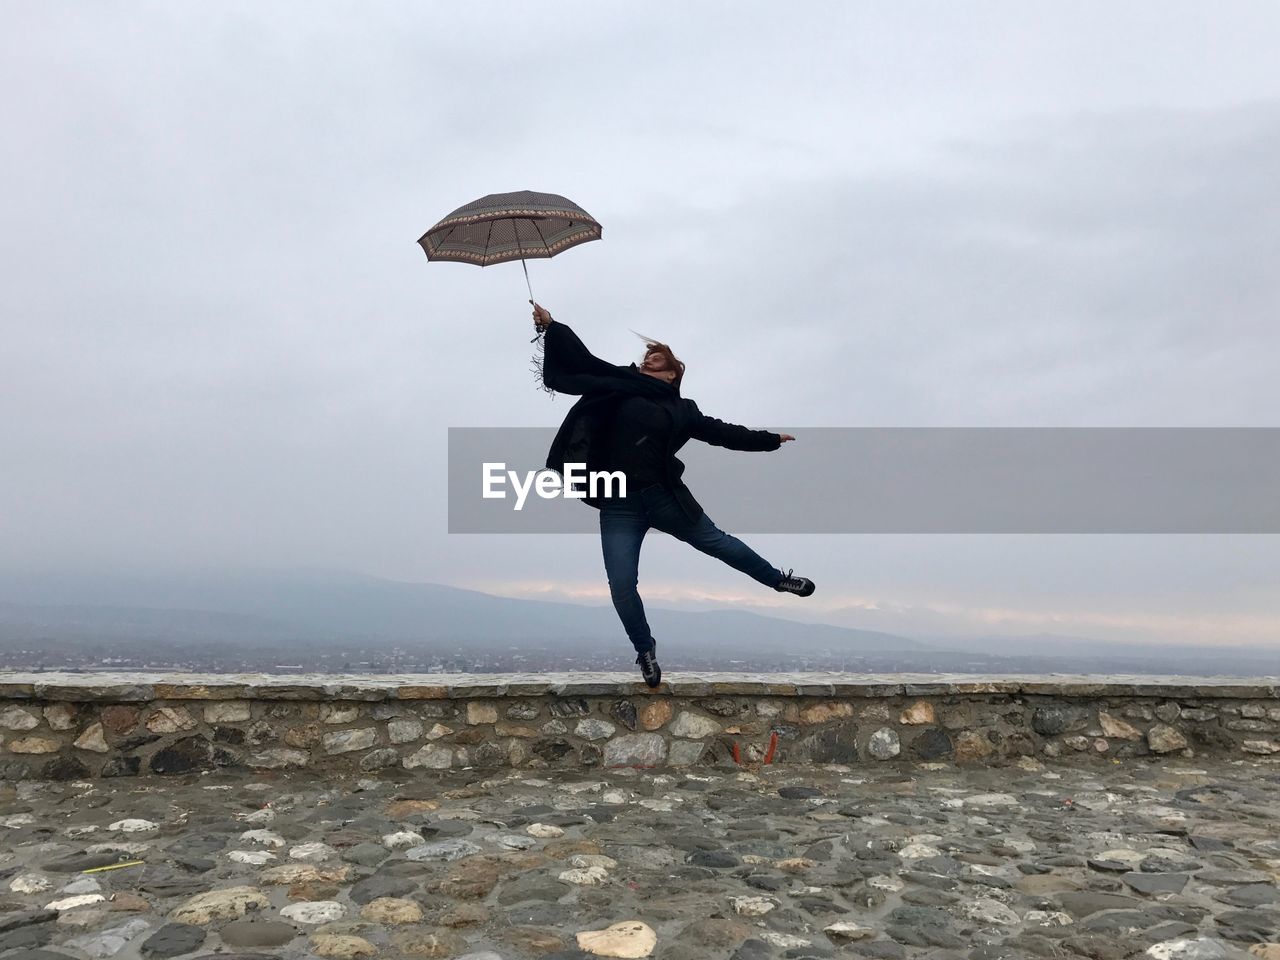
530, 301, 814, 687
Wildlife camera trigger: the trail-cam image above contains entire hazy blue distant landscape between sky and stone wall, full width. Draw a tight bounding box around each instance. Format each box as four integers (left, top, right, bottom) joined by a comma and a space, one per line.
0, 572, 1280, 676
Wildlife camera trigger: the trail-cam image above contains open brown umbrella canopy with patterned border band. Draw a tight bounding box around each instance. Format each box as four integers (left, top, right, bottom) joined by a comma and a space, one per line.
419, 189, 602, 266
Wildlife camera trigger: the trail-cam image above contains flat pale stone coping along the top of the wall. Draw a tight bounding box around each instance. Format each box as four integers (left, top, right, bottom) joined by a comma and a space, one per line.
0, 671, 1280, 701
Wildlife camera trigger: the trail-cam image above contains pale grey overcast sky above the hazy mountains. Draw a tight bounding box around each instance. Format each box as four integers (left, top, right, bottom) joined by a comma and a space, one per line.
0, 0, 1280, 648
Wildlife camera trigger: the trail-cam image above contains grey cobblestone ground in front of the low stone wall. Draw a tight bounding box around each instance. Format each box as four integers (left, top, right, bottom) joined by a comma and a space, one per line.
0, 759, 1280, 960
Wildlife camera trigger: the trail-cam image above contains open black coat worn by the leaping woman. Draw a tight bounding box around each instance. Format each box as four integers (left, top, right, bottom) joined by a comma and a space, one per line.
541, 320, 782, 522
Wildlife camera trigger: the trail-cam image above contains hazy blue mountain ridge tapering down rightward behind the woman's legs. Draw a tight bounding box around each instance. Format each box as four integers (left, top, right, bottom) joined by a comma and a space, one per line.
0, 575, 924, 652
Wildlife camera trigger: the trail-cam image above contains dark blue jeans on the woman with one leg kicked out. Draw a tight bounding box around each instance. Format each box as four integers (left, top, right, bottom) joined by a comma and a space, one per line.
600, 485, 782, 653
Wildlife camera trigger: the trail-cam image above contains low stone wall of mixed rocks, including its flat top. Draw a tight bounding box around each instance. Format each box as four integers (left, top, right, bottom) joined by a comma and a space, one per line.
0, 673, 1280, 780
